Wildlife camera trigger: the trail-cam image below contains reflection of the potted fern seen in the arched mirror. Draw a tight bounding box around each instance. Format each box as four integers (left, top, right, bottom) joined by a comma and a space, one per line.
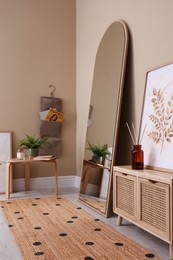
86, 142, 111, 164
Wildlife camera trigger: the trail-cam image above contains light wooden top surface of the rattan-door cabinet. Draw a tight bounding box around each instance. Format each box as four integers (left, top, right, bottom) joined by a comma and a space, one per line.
114, 165, 173, 181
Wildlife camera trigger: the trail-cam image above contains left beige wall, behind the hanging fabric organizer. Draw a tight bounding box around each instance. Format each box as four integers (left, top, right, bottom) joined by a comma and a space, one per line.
0, 0, 76, 177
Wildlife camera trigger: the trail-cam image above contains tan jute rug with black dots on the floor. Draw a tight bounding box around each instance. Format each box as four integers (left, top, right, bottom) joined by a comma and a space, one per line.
0, 196, 159, 260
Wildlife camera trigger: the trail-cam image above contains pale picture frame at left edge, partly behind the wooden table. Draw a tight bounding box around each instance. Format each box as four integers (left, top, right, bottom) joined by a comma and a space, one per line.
0, 131, 12, 194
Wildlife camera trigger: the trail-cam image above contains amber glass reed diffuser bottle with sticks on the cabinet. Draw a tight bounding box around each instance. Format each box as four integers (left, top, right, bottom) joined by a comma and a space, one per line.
126, 123, 146, 170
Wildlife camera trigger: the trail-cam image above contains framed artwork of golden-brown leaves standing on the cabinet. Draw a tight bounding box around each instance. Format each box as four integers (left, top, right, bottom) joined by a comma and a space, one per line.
139, 62, 173, 172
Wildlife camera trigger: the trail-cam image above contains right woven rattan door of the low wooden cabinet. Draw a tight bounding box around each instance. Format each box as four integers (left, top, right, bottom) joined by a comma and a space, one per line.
138, 178, 170, 241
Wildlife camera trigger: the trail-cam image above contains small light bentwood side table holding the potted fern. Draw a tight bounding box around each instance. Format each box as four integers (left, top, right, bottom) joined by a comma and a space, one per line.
6, 158, 58, 199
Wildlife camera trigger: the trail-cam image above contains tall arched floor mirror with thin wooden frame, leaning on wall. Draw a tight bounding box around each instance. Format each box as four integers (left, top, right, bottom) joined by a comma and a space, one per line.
79, 20, 128, 216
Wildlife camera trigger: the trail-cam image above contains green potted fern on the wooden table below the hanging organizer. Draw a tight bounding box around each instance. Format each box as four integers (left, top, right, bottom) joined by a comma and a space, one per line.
19, 134, 48, 157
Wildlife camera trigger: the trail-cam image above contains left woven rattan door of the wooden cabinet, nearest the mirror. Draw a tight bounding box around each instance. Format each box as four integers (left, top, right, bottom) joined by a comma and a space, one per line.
113, 172, 137, 222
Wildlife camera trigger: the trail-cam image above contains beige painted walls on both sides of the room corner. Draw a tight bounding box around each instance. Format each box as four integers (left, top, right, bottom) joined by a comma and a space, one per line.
0, 0, 173, 177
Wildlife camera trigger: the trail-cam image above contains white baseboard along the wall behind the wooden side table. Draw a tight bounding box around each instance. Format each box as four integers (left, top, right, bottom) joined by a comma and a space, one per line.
13, 176, 80, 191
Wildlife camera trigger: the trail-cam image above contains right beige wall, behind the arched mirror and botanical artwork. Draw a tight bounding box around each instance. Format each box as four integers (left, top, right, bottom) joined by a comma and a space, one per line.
76, 0, 173, 175
